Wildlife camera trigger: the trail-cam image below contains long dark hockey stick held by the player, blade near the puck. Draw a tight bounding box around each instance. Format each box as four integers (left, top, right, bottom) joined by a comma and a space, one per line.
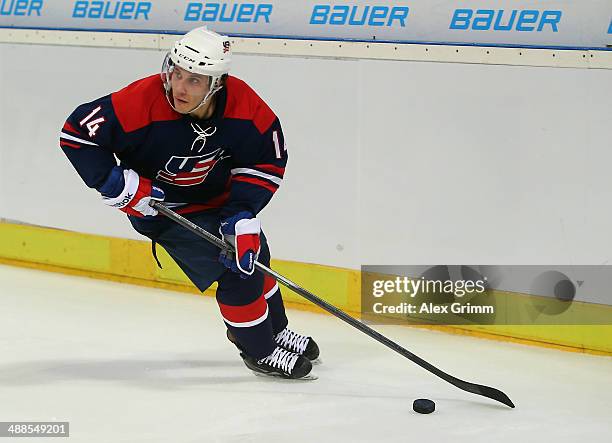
151, 200, 514, 408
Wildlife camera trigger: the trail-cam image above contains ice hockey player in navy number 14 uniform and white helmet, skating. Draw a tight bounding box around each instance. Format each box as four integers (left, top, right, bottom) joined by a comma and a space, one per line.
60, 27, 319, 379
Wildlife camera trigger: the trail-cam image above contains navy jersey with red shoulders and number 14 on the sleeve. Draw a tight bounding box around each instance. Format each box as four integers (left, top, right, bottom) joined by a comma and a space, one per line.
60, 75, 287, 217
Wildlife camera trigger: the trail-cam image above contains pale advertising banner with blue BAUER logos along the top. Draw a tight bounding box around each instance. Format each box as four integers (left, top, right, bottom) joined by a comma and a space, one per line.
0, 0, 612, 48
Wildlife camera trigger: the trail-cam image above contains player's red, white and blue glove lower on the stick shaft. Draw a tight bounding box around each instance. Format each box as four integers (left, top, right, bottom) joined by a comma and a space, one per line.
219, 211, 261, 278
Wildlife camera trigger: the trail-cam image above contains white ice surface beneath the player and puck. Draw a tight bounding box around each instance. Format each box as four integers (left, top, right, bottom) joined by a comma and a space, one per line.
0, 266, 612, 443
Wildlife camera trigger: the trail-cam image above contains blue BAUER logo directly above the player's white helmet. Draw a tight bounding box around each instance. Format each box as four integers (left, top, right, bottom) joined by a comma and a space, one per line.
184, 2, 272, 23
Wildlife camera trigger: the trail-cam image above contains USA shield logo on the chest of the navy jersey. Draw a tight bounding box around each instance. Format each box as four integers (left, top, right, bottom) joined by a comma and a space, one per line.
156, 148, 228, 186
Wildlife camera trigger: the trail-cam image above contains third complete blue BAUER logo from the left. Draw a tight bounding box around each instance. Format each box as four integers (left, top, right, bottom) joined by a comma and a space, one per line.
310, 4, 410, 27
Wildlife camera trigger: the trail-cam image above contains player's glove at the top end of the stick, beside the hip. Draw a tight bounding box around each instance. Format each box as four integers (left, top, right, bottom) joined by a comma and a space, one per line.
99, 166, 165, 217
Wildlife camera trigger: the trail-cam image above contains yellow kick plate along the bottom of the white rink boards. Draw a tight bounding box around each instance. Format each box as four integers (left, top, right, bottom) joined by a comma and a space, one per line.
0, 223, 612, 355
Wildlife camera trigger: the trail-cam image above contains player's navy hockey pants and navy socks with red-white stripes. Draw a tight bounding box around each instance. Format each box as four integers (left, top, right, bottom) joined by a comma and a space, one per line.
128, 211, 288, 358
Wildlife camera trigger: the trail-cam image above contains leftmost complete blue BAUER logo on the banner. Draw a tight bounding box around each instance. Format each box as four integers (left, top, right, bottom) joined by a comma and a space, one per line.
72, 0, 152, 20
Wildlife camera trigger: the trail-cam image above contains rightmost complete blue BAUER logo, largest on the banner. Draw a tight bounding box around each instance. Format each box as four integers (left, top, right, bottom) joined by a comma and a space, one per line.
449, 9, 563, 32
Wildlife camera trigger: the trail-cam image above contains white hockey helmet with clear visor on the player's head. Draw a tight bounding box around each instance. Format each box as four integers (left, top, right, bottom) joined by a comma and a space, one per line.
161, 26, 232, 112
